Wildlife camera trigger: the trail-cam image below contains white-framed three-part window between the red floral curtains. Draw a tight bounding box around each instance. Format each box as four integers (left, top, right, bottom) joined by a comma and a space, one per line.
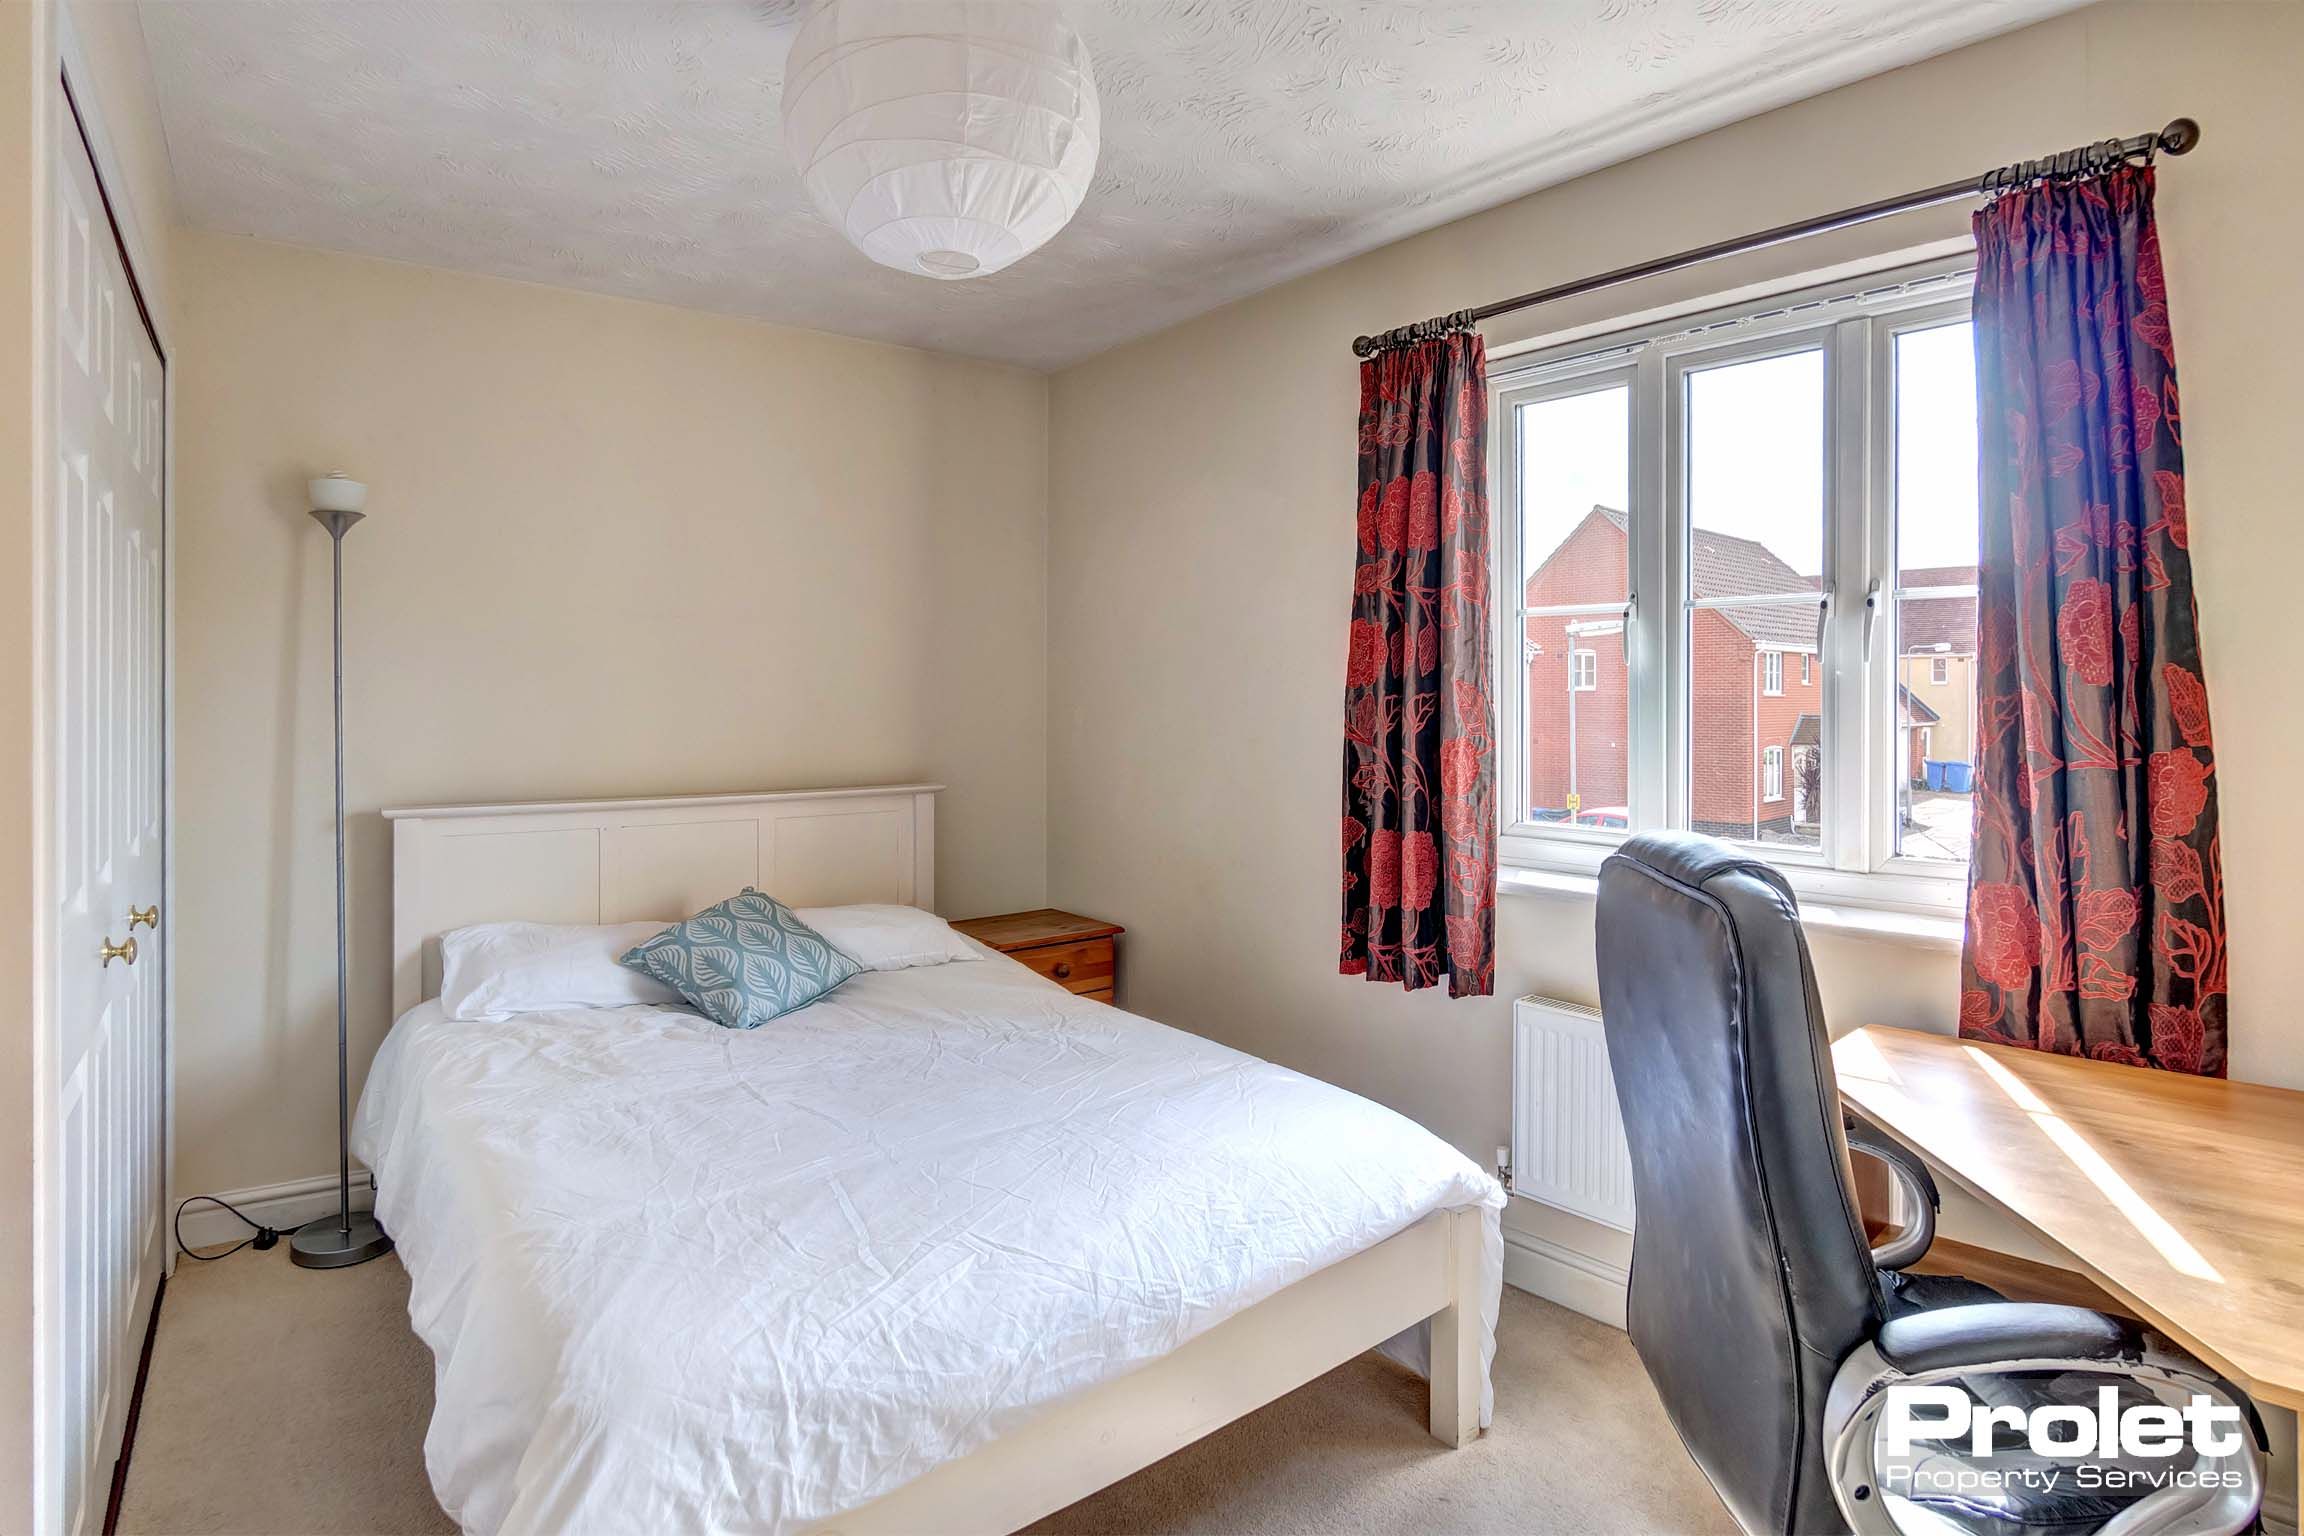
1491, 265, 1977, 910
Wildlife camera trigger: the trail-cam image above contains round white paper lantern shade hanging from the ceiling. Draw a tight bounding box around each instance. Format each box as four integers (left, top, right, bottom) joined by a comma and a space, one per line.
783, 0, 1099, 279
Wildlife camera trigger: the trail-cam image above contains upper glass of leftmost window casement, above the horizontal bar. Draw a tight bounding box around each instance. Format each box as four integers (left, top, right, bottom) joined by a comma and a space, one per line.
1518, 385, 1631, 608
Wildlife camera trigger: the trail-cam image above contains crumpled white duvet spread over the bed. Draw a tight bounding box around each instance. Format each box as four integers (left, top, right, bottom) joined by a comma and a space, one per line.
353, 951, 1505, 1534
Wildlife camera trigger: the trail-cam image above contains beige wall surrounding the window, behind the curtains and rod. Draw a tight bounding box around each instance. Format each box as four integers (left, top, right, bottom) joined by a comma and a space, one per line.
1048, 5, 2304, 1271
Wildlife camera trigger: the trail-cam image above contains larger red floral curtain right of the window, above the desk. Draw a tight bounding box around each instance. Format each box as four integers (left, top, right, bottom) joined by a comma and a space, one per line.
1961, 166, 2226, 1075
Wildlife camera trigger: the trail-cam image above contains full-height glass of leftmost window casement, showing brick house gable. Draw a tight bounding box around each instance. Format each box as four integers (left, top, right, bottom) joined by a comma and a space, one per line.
1516, 385, 1631, 829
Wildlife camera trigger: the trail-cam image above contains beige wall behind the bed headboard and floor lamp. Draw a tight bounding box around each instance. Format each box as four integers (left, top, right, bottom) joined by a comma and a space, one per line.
175, 233, 1046, 1193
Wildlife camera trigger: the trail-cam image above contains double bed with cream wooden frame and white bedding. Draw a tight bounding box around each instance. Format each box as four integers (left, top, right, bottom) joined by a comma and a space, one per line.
353, 785, 1502, 1534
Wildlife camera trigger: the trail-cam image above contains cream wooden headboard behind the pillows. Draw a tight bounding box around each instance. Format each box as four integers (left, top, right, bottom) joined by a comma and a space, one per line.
385, 783, 945, 1016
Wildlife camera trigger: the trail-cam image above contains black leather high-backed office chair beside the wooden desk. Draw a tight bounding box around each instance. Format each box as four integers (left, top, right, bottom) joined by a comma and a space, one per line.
1599, 834, 2263, 1536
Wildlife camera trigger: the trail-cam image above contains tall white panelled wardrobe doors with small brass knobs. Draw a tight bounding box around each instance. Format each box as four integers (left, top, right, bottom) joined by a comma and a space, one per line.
39, 81, 168, 1536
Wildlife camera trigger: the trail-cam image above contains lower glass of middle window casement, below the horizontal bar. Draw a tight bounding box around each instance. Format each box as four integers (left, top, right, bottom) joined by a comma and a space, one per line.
1689, 601, 1825, 847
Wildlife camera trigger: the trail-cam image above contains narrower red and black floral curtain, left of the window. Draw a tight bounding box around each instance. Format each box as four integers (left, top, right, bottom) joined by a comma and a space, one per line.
1336, 332, 1495, 997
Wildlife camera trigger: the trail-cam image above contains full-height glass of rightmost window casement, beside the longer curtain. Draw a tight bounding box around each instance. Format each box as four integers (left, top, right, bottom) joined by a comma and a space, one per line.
1894, 320, 1977, 864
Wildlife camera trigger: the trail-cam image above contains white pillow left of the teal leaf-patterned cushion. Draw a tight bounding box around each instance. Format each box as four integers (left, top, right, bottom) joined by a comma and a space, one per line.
440, 923, 680, 1020
